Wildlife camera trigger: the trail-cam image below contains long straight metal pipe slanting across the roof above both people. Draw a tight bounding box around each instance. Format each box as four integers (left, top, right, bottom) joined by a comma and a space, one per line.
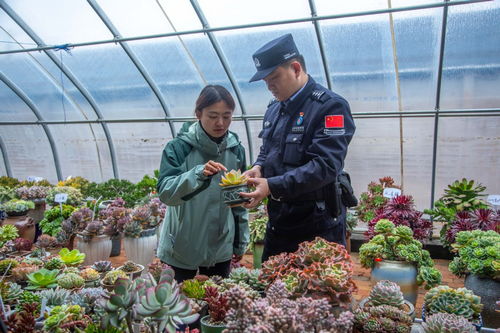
0, 0, 492, 54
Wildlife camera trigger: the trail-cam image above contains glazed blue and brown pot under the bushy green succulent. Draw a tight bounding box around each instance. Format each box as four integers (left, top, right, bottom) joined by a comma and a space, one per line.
370, 260, 418, 305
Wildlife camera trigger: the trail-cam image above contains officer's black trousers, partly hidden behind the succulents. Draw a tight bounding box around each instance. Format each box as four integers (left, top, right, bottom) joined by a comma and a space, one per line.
262, 202, 346, 262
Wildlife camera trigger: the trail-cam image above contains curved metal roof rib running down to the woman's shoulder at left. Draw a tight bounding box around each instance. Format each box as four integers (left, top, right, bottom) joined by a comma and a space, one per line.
87, 0, 176, 138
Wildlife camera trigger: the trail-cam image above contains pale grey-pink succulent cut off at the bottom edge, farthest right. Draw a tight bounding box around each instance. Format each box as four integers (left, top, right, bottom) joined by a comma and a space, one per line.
422, 313, 476, 333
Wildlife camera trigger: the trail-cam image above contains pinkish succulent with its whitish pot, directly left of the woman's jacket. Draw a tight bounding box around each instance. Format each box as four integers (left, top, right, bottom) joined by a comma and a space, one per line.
121, 201, 163, 266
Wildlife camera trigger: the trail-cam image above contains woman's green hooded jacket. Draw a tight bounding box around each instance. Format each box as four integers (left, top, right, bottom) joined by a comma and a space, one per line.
157, 122, 249, 270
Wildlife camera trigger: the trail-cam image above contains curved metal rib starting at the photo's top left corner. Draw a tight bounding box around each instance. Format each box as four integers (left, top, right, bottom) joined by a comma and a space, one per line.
0, 1, 120, 178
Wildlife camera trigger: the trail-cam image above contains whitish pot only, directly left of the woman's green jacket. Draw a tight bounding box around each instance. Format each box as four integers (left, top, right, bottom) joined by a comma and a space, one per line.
123, 228, 158, 267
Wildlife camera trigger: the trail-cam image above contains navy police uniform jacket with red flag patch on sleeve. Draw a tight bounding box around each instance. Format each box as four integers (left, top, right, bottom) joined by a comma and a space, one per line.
255, 77, 355, 234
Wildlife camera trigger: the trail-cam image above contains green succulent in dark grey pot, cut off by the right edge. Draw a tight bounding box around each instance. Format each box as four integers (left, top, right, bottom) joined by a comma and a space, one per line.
449, 230, 500, 327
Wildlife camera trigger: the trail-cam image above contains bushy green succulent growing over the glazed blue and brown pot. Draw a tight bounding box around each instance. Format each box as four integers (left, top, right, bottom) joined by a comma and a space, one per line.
359, 219, 441, 289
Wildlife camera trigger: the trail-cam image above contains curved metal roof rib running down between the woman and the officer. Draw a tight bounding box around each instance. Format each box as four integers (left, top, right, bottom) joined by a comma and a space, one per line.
190, 0, 254, 164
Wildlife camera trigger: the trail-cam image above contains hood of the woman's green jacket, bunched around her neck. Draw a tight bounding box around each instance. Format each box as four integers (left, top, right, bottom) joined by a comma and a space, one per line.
178, 121, 240, 156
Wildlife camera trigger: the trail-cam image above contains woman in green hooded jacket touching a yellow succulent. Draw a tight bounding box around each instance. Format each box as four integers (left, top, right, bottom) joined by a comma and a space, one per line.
157, 85, 249, 282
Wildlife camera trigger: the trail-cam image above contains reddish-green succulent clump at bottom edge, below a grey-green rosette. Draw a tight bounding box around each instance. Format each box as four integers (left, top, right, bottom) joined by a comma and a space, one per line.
354, 305, 413, 333
